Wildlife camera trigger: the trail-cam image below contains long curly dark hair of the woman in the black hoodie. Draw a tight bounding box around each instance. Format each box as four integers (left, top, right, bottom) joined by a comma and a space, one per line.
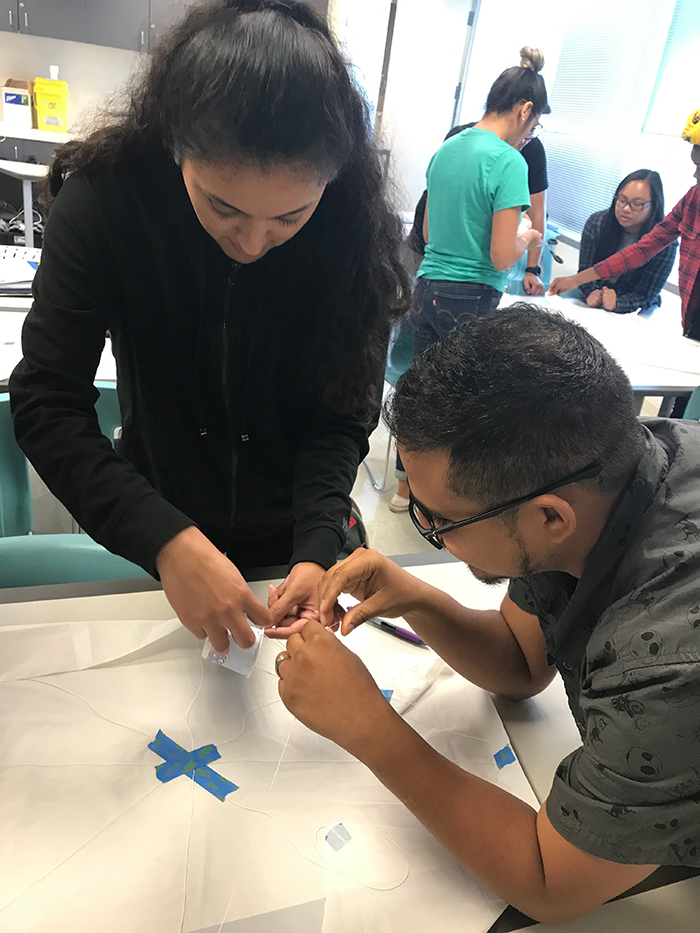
44, 0, 410, 411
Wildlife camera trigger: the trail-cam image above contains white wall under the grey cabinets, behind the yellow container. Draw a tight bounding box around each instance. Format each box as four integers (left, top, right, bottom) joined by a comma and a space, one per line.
0, 32, 140, 131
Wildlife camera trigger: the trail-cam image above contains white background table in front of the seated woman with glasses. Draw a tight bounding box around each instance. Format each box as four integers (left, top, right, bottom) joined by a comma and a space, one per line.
501, 295, 700, 411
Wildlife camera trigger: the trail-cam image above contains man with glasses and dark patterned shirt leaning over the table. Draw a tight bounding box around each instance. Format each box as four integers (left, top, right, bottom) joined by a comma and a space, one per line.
278, 304, 700, 923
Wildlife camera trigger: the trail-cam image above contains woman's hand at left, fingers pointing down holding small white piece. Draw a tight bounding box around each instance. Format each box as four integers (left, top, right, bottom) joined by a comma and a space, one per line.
156, 526, 272, 651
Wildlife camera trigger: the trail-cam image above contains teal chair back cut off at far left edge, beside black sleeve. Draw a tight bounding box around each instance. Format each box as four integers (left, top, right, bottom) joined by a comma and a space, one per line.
0, 393, 34, 537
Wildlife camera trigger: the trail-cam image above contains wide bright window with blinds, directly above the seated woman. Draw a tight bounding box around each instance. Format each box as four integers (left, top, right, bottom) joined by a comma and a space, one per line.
543, 0, 680, 233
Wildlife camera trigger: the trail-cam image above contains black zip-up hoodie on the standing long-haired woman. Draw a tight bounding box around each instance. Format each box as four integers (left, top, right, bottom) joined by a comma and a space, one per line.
10, 152, 372, 574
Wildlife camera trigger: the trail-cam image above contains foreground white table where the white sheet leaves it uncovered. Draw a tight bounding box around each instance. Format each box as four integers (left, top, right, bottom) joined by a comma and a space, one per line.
0, 554, 700, 933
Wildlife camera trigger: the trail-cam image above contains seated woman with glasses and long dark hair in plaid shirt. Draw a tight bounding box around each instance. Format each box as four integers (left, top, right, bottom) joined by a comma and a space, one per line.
578, 168, 676, 314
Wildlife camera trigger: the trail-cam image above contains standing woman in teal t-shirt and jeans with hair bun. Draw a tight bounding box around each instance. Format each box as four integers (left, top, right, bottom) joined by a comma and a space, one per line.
389, 49, 550, 512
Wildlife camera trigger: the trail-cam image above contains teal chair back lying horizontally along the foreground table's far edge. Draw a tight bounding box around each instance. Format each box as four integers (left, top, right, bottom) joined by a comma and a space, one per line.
0, 534, 148, 589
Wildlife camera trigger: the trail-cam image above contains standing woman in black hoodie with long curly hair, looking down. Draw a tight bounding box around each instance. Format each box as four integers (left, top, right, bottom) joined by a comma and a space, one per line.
10, 0, 410, 651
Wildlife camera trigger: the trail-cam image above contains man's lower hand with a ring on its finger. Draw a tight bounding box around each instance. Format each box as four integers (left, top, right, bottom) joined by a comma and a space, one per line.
278, 619, 396, 757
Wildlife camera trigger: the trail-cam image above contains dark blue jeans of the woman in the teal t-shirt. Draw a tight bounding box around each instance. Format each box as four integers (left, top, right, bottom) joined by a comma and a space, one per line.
396, 278, 502, 480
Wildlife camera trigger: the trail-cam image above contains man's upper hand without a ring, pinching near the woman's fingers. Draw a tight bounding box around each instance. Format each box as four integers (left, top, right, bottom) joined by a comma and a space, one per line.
319, 548, 425, 635
